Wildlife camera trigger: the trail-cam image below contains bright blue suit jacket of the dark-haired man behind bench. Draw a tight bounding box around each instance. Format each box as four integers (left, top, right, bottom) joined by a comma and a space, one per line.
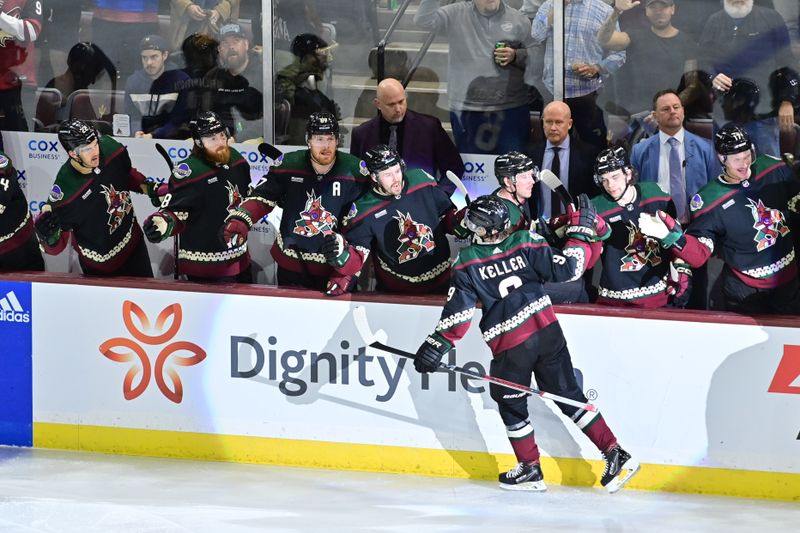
631, 130, 722, 202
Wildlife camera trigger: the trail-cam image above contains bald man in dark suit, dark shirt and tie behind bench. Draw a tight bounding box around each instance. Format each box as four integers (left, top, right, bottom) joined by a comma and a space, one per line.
350, 78, 464, 194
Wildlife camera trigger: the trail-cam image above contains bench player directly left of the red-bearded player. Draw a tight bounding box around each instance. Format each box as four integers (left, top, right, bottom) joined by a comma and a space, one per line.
35, 119, 155, 278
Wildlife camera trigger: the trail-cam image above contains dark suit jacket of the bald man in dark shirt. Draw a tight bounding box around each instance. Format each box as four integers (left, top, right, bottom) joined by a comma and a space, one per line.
350, 109, 464, 194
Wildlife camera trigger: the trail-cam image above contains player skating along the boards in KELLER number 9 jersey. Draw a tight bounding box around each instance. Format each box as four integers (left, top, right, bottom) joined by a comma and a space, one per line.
414, 195, 638, 492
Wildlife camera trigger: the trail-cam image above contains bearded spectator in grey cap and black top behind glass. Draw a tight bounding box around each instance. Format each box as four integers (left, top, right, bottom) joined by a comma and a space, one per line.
205, 23, 264, 142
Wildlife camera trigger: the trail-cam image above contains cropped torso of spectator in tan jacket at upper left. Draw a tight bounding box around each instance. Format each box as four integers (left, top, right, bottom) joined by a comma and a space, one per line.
169, 0, 239, 50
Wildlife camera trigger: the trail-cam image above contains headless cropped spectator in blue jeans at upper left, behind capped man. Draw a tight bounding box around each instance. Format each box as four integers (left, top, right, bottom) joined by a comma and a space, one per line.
92, 0, 158, 77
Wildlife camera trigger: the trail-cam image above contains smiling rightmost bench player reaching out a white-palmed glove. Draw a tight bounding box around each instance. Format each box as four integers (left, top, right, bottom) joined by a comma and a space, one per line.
639, 125, 800, 314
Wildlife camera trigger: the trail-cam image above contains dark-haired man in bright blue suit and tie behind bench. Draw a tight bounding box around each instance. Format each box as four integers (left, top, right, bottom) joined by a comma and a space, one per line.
631, 89, 722, 309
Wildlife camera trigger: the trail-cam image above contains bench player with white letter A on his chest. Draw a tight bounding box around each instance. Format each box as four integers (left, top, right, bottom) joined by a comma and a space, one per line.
224, 111, 368, 292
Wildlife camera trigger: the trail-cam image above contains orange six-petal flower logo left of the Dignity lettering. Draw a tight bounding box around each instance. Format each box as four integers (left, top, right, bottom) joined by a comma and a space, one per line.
99, 300, 206, 403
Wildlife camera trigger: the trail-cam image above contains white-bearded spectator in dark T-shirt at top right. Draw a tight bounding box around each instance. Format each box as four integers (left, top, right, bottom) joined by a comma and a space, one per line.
699, 0, 797, 130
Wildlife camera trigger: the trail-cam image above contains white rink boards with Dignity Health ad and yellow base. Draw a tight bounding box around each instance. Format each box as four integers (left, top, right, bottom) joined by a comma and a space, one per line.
0, 275, 800, 501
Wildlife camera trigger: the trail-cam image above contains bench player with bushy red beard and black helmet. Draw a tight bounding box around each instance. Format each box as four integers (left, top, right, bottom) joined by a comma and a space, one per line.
144, 111, 252, 283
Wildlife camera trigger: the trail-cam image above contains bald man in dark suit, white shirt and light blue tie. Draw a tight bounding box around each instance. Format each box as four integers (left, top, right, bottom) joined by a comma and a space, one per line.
531, 100, 600, 219
